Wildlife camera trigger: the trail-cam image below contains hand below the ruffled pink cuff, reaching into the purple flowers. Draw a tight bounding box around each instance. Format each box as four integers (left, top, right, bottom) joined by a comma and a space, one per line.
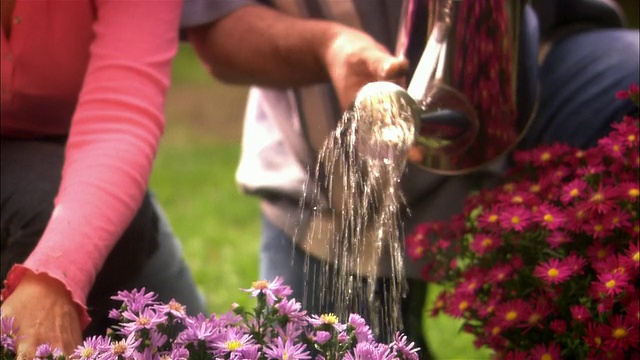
2, 272, 82, 359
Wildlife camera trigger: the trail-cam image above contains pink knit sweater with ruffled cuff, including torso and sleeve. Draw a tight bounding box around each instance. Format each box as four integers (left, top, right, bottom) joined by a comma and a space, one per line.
1, 0, 182, 326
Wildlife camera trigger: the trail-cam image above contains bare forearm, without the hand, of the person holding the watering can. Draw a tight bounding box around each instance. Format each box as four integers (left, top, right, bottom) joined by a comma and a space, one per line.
188, 5, 344, 87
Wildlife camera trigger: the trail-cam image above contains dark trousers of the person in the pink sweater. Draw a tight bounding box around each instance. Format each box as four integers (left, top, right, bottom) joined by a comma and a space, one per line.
0, 138, 206, 336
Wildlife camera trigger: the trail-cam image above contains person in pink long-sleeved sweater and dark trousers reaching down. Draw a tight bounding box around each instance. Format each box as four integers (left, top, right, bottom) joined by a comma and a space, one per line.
0, 0, 205, 358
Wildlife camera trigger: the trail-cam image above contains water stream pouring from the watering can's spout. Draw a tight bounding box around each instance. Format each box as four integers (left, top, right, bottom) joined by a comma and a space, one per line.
298, 97, 414, 334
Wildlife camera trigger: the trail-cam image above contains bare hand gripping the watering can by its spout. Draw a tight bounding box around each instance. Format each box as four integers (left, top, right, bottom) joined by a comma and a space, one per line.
324, 26, 409, 110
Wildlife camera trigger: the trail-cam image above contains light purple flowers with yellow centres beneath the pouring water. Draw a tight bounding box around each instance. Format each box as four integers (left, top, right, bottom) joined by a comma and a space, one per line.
0, 278, 419, 360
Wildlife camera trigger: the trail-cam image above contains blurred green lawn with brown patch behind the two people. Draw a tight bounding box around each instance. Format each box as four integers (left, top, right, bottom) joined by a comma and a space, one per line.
151, 46, 489, 359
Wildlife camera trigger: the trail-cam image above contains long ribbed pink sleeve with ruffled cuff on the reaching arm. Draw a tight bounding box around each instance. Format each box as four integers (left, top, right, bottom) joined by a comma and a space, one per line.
3, 0, 182, 326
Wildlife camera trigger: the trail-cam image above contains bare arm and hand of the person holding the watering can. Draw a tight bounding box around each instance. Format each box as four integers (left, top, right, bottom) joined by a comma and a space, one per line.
188, 5, 408, 108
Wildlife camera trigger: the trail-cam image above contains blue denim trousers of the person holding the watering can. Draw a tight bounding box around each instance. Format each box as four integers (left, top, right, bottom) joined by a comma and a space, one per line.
260, 29, 640, 359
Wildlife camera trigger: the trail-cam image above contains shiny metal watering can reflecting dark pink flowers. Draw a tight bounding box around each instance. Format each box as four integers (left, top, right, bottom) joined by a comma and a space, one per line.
354, 0, 538, 175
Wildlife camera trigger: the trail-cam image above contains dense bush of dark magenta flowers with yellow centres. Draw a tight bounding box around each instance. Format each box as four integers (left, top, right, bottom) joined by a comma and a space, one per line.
406, 85, 640, 359
